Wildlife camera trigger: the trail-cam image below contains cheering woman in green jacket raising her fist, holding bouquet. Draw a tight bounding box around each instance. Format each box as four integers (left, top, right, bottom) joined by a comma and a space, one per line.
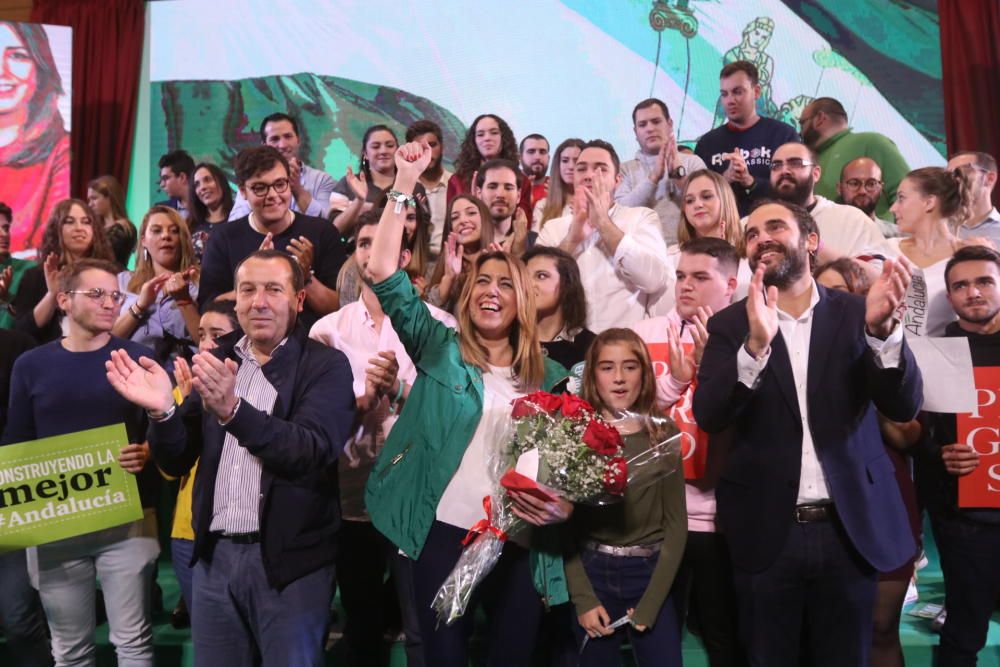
365, 138, 572, 667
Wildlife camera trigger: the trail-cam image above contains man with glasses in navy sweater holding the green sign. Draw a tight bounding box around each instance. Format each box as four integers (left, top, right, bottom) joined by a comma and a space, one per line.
0, 259, 160, 666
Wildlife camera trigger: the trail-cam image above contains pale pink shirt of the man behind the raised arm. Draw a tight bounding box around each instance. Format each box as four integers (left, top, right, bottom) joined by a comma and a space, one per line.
309, 299, 456, 521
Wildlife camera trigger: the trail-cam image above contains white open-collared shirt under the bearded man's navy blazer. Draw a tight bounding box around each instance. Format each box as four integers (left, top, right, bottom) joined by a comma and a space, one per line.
736, 282, 903, 505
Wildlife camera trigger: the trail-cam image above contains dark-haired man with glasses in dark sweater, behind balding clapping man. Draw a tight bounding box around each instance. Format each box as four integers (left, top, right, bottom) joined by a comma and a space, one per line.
198, 146, 345, 328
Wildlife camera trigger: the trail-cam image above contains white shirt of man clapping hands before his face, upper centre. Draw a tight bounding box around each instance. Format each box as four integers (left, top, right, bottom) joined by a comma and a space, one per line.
537, 204, 674, 333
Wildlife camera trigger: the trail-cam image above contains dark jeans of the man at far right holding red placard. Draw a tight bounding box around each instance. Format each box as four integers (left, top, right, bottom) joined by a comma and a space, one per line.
931, 513, 1000, 667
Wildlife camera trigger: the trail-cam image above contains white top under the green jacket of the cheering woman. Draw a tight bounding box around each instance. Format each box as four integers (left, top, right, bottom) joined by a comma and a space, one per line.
437, 366, 525, 530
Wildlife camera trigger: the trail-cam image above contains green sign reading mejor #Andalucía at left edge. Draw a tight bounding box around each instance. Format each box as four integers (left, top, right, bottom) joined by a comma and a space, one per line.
0, 424, 142, 552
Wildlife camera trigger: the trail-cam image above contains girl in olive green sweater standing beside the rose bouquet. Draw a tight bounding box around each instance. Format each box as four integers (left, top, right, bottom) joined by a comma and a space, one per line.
566, 329, 687, 667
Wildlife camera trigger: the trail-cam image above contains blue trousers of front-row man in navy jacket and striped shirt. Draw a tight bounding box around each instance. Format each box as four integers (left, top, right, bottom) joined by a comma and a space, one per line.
191, 539, 333, 667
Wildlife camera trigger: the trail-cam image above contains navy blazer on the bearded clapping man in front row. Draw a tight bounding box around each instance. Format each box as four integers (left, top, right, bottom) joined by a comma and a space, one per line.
693, 286, 923, 572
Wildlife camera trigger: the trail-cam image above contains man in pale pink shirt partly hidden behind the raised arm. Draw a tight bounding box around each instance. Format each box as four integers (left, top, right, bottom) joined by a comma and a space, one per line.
309, 215, 457, 666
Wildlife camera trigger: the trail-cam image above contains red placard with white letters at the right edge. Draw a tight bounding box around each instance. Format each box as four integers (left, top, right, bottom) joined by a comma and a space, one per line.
956, 366, 1000, 507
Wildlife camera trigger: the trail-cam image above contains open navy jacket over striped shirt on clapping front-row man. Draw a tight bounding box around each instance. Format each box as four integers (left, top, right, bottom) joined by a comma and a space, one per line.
149, 325, 355, 590
